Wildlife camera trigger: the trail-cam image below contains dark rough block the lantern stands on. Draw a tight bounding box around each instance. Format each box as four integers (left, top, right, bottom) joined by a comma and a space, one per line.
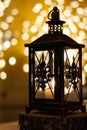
19, 112, 87, 130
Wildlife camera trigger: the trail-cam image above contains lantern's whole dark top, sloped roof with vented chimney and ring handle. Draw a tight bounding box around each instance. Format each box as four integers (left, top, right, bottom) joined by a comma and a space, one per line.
25, 7, 84, 48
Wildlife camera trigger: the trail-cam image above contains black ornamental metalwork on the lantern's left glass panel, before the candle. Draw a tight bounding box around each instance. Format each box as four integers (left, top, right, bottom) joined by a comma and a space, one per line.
35, 53, 54, 92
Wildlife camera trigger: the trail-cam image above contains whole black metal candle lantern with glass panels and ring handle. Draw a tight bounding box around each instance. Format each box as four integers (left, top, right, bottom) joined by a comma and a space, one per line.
25, 7, 85, 113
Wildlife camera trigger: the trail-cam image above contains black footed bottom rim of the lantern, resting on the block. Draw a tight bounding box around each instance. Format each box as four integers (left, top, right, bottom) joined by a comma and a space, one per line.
26, 105, 86, 115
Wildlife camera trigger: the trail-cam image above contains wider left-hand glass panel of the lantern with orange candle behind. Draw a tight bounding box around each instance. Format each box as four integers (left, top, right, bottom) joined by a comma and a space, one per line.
34, 50, 55, 99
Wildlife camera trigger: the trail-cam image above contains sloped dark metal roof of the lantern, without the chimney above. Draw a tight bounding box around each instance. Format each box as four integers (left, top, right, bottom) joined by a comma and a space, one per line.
25, 33, 85, 48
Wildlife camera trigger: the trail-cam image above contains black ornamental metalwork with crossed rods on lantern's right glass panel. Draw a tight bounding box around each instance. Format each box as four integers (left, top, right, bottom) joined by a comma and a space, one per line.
66, 52, 81, 99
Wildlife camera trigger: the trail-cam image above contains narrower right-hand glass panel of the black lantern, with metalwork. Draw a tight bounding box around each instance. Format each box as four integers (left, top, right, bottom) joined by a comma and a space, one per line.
64, 49, 81, 102
